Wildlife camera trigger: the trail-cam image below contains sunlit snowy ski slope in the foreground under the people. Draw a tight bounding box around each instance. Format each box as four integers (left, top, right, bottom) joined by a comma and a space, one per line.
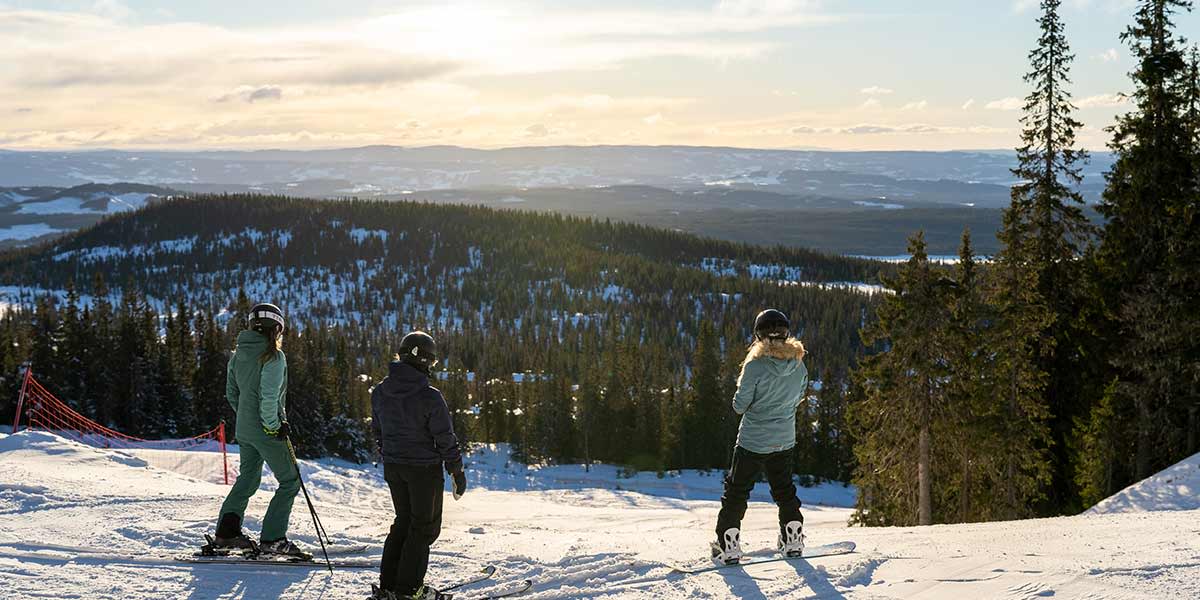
0, 432, 1200, 600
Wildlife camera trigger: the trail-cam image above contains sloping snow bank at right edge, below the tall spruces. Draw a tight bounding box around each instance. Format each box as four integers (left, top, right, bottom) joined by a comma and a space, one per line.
1087, 454, 1200, 515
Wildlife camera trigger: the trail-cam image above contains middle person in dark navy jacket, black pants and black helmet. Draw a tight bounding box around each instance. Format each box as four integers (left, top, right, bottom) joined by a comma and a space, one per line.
371, 331, 467, 600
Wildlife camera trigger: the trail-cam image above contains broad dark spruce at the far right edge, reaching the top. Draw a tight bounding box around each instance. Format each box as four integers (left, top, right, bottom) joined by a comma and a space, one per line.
1092, 0, 1200, 482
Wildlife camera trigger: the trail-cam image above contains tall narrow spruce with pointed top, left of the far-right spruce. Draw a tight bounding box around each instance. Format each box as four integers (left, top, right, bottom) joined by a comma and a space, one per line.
997, 0, 1093, 511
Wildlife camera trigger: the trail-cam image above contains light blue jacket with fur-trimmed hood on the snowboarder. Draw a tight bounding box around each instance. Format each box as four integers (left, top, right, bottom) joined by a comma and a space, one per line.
733, 340, 809, 454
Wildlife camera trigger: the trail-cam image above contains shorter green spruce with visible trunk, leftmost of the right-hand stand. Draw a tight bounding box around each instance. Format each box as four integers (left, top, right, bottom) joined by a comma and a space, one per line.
850, 232, 948, 524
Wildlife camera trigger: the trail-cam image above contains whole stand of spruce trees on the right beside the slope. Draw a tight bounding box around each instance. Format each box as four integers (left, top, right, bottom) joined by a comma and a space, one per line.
850, 0, 1200, 524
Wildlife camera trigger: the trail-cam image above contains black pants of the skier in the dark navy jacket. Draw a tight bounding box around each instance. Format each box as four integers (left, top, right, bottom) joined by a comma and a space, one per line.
379, 463, 445, 596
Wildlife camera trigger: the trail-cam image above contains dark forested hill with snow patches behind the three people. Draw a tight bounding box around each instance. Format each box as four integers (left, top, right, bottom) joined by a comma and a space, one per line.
0, 196, 890, 475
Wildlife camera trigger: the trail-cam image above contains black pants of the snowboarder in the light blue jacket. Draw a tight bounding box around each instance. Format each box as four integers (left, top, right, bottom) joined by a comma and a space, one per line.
716, 446, 804, 540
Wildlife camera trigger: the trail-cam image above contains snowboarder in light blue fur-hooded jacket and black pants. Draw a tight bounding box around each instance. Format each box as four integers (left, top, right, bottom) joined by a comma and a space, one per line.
713, 308, 809, 564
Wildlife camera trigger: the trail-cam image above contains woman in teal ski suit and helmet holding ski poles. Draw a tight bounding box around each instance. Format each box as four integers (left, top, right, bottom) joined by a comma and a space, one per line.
214, 304, 311, 558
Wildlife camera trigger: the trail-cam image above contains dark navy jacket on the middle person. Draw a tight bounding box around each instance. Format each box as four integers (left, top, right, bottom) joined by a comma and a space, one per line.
371, 361, 462, 472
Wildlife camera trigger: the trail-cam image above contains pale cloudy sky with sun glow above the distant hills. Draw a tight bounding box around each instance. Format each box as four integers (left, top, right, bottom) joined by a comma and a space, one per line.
0, 0, 1200, 150
